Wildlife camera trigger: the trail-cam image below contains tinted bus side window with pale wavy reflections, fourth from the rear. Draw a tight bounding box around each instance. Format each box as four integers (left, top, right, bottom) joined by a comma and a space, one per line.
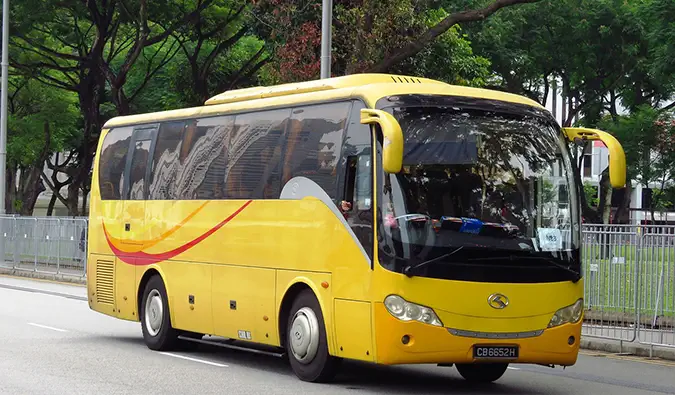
175, 117, 234, 200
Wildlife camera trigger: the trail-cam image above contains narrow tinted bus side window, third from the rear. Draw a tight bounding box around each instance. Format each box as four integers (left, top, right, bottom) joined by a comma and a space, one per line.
148, 121, 185, 200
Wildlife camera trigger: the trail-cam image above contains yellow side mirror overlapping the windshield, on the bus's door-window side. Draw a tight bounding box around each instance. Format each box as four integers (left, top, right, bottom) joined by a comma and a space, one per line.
361, 108, 403, 174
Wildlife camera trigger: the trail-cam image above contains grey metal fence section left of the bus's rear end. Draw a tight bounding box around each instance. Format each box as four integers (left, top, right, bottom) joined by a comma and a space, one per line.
0, 216, 87, 277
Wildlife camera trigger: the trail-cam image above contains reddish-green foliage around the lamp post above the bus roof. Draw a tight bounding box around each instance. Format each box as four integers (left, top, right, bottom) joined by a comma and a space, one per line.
256, 0, 490, 86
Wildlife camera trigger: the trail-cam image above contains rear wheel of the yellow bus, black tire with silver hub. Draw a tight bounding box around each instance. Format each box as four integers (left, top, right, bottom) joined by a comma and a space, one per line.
140, 276, 179, 351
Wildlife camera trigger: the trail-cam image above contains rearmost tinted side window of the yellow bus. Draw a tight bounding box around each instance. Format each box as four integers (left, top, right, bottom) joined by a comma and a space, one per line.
98, 127, 132, 200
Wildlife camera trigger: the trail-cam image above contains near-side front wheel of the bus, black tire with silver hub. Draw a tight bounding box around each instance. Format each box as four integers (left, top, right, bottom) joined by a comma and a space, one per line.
284, 290, 340, 383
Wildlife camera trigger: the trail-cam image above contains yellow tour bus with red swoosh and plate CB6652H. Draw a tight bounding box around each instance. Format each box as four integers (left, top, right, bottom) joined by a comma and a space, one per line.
87, 74, 626, 382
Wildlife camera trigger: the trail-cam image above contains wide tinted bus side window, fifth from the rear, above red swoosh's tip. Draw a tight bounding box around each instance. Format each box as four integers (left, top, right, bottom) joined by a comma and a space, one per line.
225, 110, 290, 199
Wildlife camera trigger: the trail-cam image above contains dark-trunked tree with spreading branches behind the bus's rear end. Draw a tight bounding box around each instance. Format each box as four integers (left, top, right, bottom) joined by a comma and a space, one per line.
10, 0, 224, 215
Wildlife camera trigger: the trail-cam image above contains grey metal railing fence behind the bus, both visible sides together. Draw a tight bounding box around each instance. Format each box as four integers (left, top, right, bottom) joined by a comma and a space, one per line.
0, 216, 675, 347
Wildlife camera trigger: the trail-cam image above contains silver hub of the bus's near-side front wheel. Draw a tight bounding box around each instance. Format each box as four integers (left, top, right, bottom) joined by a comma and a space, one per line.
290, 307, 319, 364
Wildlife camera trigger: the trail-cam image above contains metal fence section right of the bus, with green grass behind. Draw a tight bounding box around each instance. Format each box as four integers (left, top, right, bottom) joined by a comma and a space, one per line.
582, 225, 675, 348
